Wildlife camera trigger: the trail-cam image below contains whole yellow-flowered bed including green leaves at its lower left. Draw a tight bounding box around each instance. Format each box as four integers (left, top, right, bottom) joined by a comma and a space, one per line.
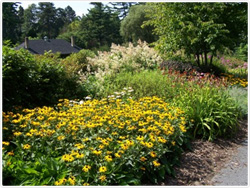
3, 97, 186, 185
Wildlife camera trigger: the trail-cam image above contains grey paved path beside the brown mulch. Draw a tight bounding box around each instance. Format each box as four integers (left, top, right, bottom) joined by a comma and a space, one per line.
211, 140, 248, 186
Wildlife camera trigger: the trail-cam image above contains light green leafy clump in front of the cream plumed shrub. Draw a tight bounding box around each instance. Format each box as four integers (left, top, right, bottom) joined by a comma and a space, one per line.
92, 70, 173, 99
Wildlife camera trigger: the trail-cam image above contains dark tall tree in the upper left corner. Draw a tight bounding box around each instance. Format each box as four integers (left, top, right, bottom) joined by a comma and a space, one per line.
2, 2, 22, 44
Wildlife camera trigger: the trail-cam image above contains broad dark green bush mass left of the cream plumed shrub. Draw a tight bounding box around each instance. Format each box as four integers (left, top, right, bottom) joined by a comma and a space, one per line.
3, 46, 85, 111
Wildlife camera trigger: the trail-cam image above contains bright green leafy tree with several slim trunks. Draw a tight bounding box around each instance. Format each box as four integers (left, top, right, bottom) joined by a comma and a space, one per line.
147, 3, 240, 65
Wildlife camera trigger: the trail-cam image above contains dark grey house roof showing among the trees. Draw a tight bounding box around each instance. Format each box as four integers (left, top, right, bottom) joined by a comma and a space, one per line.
16, 39, 81, 55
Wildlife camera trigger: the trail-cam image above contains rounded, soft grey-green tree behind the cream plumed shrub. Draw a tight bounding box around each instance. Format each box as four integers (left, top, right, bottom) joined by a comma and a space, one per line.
120, 5, 157, 43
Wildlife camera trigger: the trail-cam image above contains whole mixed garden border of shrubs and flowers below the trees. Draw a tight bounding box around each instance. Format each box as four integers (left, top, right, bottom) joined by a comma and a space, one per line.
2, 41, 248, 185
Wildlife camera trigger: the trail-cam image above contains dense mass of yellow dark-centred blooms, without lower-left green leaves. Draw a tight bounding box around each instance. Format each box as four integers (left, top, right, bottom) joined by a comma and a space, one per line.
3, 97, 186, 185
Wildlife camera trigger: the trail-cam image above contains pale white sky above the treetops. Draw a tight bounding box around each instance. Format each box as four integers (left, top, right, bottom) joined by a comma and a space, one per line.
18, 0, 98, 16
